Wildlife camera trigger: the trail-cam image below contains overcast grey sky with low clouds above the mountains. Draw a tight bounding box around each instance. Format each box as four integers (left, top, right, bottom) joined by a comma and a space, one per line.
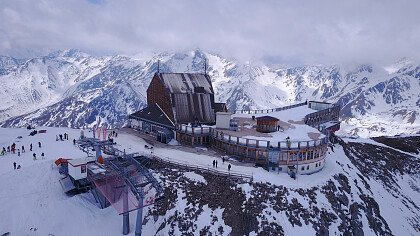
0, 0, 420, 64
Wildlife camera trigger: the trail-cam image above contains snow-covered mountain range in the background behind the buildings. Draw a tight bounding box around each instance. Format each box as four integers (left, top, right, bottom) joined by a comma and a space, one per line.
0, 49, 420, 136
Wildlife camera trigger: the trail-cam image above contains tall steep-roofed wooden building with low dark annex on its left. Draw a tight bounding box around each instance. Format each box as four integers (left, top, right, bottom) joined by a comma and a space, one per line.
129, 73, 227, 142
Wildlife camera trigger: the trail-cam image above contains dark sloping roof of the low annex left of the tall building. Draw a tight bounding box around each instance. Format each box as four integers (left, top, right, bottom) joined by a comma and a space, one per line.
130, 104, 175, 128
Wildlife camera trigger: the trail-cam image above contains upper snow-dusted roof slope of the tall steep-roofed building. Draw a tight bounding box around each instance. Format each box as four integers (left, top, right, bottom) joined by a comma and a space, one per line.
158, 73, 213, 94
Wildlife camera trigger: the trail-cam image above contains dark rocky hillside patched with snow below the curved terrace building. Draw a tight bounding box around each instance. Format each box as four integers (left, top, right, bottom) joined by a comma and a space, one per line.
139, 137, 420, 235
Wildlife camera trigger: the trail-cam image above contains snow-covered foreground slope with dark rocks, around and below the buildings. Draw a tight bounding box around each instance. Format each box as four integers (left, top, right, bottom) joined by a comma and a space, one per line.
0, 128, 420, 235
